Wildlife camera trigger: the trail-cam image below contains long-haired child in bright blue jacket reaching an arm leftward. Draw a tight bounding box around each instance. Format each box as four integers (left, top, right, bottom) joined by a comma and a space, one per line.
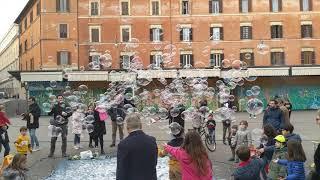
273, 140, 307, 180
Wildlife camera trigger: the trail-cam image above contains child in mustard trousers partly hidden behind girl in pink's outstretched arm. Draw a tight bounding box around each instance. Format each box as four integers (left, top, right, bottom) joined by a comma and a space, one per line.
159, 122, 183, 180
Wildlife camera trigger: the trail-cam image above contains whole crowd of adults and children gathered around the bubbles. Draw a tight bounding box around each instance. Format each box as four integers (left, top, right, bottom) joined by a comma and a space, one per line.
0, 95, 320, 180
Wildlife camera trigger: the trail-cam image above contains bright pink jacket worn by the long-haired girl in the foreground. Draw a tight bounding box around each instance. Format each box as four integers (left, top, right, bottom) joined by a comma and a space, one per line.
164, 145, 213, 180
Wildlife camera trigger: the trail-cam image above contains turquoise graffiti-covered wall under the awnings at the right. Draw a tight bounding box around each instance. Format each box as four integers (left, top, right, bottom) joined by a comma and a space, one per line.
237, 85, 320, 111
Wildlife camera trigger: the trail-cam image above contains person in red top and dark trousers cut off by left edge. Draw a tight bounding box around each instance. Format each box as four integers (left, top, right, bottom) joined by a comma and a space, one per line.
0, 104, 11, 157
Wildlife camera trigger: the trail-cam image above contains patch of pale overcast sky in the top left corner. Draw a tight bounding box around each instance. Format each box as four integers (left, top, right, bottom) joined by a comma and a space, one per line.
0, 0, 28, 41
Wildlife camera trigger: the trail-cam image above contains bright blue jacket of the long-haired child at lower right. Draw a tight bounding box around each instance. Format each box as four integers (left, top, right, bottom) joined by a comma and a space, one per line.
278, 159, 306, 180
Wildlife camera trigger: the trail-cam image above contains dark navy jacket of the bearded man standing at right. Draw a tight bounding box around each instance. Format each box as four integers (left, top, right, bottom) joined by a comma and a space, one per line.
263, 108, 284, 130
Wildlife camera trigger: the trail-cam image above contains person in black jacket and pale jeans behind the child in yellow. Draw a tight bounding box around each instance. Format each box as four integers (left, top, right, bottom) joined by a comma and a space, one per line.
22, 96, 41, 151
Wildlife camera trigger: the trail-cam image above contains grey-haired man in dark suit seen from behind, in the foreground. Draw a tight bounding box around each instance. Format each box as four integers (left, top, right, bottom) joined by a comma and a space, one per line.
117, 113, 158, 180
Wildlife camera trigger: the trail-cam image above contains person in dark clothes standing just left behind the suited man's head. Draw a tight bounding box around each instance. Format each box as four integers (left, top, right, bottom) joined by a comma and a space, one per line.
108, 105, 126, 147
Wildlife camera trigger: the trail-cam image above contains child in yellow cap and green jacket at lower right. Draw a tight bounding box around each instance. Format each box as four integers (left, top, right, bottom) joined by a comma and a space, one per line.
268, 135, 287, 179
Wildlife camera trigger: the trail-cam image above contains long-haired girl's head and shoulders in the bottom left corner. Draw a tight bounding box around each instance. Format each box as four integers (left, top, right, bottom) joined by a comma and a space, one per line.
2, 154, 27, 180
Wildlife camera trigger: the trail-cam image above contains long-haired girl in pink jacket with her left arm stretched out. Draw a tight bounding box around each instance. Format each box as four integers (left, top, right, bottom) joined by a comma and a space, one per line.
164, 131, 212, 180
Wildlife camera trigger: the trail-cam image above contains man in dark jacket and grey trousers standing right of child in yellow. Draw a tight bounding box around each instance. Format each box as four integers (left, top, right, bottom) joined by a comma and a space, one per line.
48, 95, 72, 158
